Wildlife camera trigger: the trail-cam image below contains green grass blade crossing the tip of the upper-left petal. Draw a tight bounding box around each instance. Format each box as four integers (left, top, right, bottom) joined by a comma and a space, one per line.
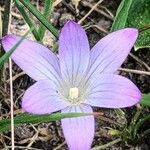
0, 30, 31, 69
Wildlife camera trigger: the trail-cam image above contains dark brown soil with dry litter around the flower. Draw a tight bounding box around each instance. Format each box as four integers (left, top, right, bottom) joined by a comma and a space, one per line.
0, 0, 150, 150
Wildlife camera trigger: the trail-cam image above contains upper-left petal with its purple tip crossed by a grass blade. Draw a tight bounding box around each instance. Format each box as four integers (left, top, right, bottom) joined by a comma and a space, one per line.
2, 35, 60, 81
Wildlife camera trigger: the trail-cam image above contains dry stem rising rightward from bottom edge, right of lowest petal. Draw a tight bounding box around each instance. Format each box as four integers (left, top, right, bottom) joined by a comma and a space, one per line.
91, 138, 121, 150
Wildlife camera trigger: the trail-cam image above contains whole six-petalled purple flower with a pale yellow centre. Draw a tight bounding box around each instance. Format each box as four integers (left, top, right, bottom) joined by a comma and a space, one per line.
2, 21, 141, 150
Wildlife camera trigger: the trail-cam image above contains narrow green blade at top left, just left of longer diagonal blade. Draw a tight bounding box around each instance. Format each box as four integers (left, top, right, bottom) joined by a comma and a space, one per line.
15, 0, 40, 41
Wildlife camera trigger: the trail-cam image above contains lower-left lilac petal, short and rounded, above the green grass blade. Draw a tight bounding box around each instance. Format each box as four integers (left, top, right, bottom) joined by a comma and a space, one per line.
22, 80, 68, 114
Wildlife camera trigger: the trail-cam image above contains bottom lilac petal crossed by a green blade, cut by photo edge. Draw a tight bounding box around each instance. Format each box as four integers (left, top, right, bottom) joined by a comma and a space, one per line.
61, 105, 95, 150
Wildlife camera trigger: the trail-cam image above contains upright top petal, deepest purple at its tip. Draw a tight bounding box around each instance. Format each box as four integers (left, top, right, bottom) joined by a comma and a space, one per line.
59, 21, 90, 85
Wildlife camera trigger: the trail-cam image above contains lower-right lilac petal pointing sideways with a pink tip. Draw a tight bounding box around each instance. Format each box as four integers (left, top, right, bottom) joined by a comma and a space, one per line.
85, 74, 141, 108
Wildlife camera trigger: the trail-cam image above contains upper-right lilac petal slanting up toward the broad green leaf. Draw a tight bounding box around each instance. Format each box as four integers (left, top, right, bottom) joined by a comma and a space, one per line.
88, 28, 138, 76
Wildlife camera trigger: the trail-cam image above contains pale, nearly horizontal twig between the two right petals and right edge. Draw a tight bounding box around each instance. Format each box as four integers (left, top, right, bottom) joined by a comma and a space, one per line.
118, 68, 150, 76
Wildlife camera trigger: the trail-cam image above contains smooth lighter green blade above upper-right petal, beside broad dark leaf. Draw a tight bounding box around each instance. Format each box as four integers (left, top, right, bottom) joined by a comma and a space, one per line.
111, 0, 133, 31
